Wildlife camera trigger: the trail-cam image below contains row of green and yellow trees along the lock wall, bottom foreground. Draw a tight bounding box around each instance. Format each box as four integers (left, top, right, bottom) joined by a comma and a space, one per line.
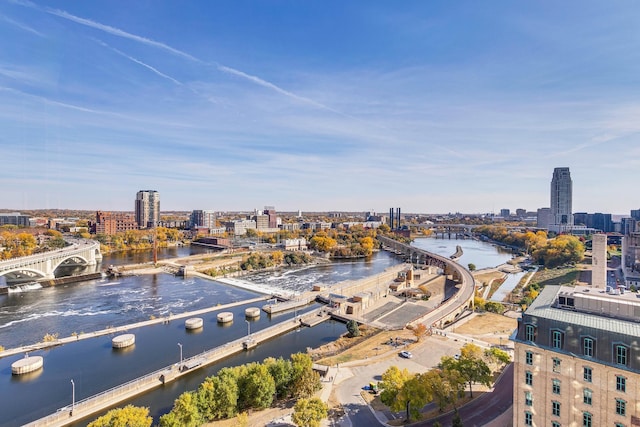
88, 353, 326, 427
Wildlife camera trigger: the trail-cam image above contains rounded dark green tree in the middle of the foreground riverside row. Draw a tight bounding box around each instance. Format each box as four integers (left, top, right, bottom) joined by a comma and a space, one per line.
238, 363, 276, 409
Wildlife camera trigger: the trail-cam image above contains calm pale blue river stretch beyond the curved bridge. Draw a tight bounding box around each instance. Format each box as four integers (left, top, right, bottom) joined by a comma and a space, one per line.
412, 237, 512, 269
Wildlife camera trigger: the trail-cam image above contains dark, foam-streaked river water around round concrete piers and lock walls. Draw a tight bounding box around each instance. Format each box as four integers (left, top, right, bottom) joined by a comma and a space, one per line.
0, 247, 400, 426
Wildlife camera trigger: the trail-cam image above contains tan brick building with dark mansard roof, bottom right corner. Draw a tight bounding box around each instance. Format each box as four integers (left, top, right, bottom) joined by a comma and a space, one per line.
512, 285, 640, 427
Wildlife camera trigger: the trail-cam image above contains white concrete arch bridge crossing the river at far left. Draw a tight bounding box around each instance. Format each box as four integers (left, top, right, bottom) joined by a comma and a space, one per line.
0, 240, 102, 284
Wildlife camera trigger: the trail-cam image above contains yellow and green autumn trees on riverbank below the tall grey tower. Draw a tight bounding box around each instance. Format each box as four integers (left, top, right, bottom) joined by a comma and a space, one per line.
474, 225, 584, 268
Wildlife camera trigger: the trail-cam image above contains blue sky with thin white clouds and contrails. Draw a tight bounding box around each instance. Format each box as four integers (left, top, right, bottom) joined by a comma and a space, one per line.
0, 0, 640, 214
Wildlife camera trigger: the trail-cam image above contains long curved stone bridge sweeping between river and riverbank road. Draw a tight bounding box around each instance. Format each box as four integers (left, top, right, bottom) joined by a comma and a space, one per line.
378, 236, 475, 324
